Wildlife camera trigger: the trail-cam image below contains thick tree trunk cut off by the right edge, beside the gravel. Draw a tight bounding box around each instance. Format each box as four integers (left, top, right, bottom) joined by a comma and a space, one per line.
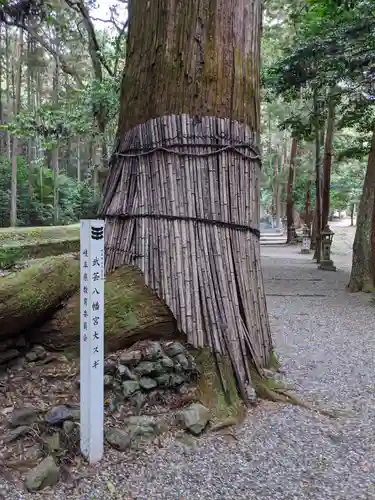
348, 122, 375, 292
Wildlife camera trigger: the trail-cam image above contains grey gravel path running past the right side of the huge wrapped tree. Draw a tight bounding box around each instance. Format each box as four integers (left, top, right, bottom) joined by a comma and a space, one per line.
0, 227, 375, 500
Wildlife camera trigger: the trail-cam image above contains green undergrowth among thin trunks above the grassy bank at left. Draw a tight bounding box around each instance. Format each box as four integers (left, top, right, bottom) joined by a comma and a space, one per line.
0, 157, 99, 227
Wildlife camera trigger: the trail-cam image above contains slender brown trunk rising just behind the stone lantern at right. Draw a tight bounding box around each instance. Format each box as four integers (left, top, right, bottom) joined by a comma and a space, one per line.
322, 91, 335, 229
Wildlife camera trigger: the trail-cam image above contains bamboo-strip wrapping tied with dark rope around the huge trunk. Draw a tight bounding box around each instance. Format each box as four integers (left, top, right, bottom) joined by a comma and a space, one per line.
101, 115, 272, 399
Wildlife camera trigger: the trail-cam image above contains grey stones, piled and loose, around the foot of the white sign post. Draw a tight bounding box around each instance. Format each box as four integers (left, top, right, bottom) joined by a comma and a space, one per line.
0, 341, 214, 492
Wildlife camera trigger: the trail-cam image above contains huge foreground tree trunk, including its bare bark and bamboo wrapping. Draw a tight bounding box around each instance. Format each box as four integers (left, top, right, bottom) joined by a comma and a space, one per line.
101, 0, 272, 400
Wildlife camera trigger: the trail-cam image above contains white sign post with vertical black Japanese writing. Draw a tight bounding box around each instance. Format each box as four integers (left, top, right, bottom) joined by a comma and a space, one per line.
80, 220, 104, 464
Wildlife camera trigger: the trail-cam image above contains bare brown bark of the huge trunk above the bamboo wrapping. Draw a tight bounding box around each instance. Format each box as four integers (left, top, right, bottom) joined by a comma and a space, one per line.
118, 0, 262, 137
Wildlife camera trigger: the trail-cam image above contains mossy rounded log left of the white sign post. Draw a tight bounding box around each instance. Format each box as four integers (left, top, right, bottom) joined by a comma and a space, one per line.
0, 255, 79, 340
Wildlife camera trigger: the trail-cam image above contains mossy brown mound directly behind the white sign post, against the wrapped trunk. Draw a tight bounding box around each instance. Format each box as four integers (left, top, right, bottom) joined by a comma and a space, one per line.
28, 266, 179, 356
